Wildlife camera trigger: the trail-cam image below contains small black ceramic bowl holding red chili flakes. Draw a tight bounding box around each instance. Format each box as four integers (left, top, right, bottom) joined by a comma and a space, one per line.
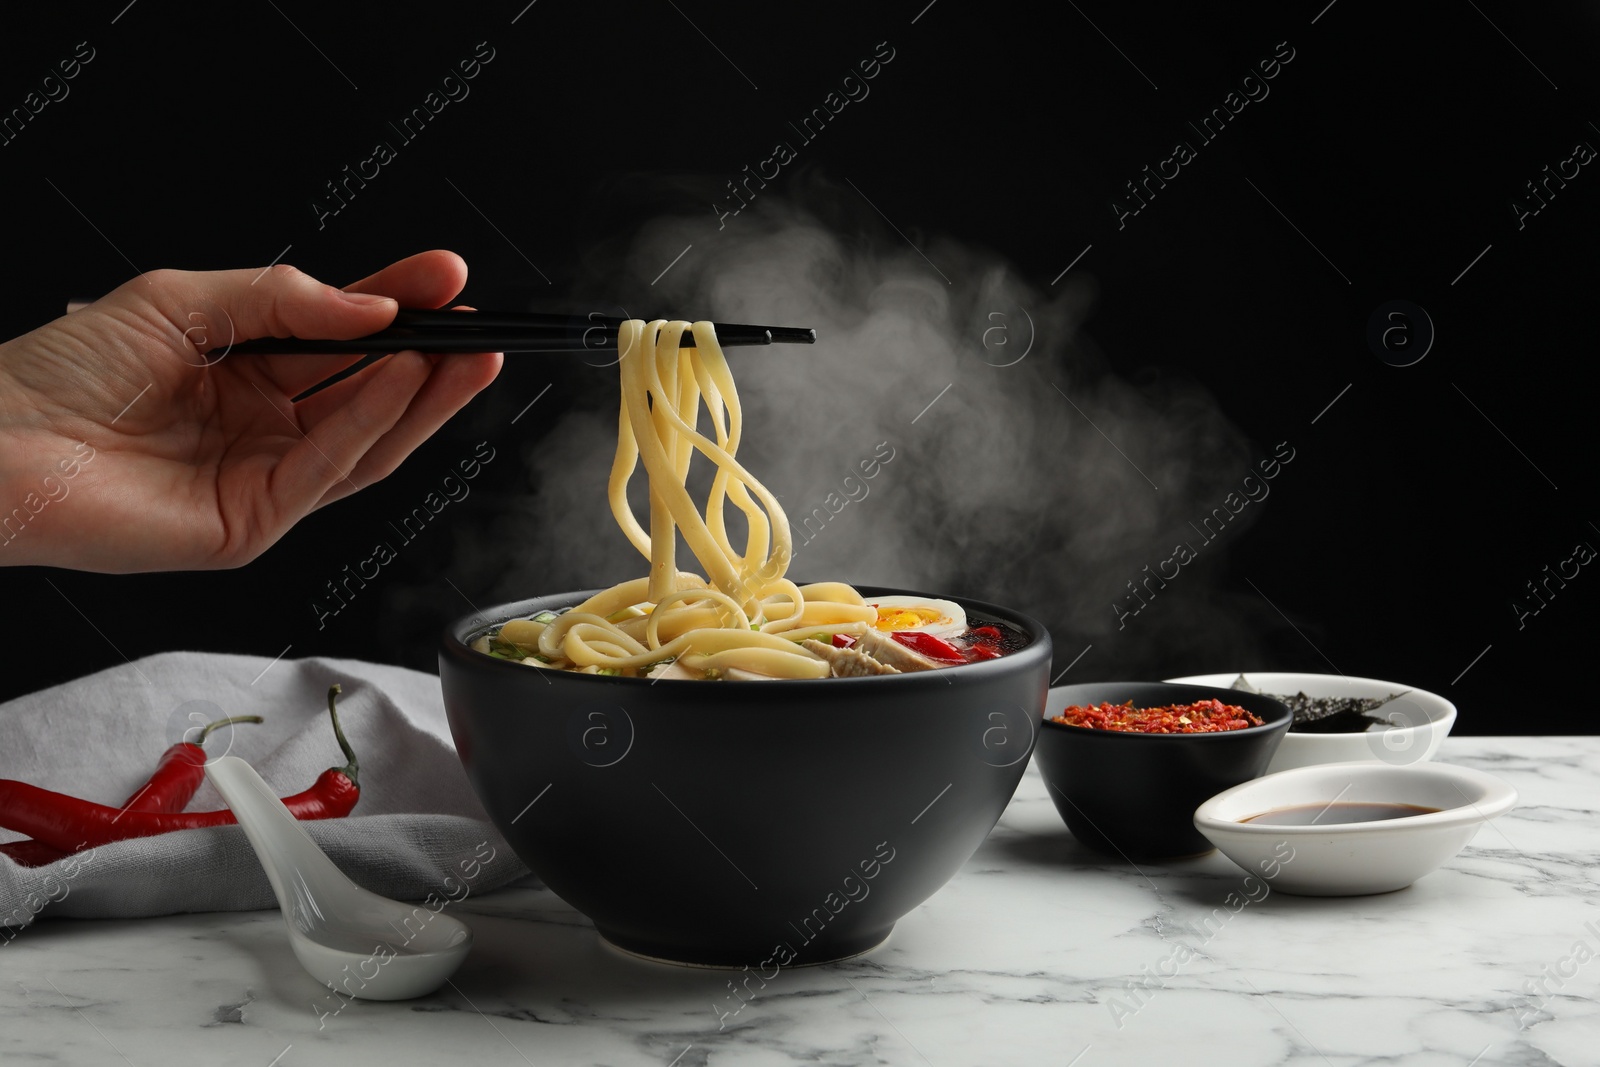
1038, 681, 1293, 859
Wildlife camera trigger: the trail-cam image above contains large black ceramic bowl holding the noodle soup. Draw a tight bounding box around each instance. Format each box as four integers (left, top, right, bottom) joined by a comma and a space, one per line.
438, 587, 1050, 971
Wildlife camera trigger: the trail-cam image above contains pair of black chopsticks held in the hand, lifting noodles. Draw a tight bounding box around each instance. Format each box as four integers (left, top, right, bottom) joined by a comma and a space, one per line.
220, 309, 816, 355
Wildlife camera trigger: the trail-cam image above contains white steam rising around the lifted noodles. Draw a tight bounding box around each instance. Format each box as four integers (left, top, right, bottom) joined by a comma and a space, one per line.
454, 178, 1266, 680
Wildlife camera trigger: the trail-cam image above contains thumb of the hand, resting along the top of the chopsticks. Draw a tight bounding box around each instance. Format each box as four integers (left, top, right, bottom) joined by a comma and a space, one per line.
106, 264, 400, 349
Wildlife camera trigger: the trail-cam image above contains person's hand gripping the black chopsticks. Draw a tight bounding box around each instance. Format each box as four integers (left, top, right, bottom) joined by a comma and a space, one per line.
0, 251, 501, 573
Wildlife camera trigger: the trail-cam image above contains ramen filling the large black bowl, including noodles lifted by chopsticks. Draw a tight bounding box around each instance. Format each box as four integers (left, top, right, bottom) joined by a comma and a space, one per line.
472, 318, 1027, 681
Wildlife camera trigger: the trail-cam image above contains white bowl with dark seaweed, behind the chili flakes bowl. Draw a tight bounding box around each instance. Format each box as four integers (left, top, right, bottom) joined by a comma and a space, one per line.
1168, 670, 1456, 774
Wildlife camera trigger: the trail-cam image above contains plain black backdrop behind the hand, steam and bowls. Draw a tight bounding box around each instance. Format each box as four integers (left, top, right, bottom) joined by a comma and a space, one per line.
0, 0, 1600, 733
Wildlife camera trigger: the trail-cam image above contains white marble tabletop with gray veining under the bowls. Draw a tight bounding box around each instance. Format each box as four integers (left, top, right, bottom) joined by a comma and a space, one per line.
0, 737, 1600, 1067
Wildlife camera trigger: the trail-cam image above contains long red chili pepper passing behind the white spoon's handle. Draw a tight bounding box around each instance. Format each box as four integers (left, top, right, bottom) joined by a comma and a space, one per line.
0, 685, 360, 851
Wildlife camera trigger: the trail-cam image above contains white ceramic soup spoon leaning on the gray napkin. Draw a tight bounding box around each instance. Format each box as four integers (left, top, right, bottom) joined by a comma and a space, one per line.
206, 755, 472, 1000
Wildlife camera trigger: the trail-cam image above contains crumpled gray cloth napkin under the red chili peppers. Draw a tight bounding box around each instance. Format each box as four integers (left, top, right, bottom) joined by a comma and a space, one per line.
0, 653, 528, 928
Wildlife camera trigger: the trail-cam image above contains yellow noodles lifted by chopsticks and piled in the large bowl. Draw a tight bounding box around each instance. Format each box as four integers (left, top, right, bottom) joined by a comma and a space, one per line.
499, 318, 878, 678
